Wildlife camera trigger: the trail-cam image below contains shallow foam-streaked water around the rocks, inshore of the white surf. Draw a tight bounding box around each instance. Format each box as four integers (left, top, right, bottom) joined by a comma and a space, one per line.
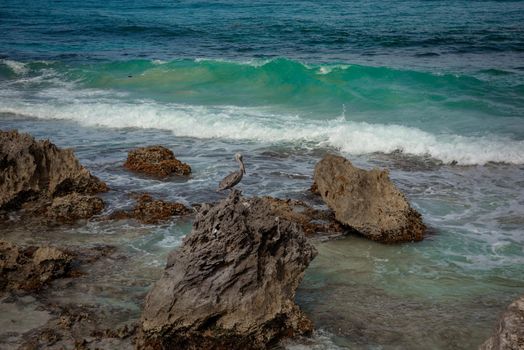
2, 116, 524, 349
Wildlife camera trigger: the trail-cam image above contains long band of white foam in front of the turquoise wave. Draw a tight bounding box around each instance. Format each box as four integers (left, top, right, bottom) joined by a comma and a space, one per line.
0, 91, 524, 165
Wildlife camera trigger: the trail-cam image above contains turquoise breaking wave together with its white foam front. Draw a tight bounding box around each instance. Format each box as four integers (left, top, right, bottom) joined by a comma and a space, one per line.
0, 58, 524, 165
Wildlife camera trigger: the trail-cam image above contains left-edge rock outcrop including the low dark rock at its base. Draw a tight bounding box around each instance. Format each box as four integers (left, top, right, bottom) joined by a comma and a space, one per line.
0, 131, 108, 223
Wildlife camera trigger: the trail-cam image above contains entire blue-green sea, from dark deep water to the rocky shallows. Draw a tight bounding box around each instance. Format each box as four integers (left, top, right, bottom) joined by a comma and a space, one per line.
0, 0, 524, 350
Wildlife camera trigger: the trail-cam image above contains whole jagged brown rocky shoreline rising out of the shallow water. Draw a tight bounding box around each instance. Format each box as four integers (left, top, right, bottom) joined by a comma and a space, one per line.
0, 131, 522, 349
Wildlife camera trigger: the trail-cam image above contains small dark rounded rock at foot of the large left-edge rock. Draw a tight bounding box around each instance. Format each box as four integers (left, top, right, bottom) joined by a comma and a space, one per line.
46, 193, 104, 222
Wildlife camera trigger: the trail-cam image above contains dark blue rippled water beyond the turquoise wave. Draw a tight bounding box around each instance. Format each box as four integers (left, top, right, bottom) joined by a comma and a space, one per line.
0, 0, 524, 70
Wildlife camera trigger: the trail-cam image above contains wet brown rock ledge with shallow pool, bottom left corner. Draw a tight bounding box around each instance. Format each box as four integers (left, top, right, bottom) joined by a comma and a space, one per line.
0, 242, 138, 350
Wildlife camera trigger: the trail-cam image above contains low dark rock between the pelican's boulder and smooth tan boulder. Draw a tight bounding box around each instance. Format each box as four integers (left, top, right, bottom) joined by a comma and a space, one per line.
262, 197, 344, 236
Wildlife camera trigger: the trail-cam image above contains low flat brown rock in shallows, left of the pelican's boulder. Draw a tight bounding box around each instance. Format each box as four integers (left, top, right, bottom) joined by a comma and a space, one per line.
106, 193, 193, 224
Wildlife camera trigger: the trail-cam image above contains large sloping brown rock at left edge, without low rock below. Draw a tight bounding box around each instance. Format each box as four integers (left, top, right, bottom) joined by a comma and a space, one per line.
0, 131, 107, 210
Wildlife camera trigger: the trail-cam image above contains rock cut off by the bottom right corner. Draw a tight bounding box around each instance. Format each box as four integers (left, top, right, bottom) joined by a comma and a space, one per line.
479, 295, 524, 350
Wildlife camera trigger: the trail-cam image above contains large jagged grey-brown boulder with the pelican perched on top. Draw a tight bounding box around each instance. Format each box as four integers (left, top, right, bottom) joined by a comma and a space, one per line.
137, 190, 316, 350
